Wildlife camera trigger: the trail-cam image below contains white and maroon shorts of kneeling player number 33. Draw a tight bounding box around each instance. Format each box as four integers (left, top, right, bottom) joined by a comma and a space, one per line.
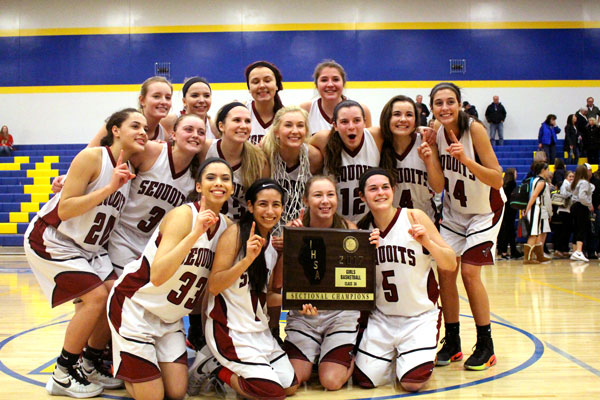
108, 291, 187, 383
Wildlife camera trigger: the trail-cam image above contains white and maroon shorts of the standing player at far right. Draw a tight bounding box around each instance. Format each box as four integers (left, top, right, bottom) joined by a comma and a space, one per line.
440, 207, 504, 265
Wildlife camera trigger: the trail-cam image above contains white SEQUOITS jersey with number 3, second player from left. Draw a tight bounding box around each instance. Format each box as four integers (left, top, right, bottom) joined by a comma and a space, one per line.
108, 143, 194, 267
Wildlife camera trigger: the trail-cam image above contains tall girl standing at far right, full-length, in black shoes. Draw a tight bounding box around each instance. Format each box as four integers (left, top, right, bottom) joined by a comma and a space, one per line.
430, 82, 506, 370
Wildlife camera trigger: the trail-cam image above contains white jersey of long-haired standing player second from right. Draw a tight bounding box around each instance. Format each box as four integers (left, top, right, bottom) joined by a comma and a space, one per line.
394, 133, 436, 221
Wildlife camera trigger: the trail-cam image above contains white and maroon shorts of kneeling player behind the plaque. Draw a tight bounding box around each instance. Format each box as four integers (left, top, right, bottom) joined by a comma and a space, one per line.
284, 311, 360, 367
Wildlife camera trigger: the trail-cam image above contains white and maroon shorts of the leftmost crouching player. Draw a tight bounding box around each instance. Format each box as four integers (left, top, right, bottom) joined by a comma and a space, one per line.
23, 229, 116, 307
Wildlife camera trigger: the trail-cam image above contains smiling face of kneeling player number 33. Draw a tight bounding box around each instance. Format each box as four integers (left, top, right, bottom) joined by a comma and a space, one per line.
196, 162, 233, 210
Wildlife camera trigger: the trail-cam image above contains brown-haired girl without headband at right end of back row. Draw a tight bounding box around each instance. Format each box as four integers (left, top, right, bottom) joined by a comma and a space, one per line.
300, 60, 371, 135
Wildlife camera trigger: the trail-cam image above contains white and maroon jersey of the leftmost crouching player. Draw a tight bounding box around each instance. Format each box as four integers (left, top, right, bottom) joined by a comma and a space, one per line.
29, 147, 131, 259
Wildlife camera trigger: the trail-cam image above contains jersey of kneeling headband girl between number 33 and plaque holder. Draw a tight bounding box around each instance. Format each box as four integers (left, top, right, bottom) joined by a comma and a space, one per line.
206, 239, 277, 333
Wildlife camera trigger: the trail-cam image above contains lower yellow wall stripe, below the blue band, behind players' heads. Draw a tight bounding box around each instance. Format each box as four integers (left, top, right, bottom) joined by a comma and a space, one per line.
0, 79, 600, 94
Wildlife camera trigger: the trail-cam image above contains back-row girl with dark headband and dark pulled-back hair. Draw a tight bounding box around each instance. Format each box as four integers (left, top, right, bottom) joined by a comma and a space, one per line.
244, 61, 283, 144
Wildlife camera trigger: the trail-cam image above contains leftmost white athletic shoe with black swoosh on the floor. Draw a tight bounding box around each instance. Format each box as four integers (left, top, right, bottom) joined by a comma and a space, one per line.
46, 365, 104, 399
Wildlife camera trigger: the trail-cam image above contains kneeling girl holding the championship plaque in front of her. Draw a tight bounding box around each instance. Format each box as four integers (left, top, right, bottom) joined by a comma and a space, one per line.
284, 175, 379, 390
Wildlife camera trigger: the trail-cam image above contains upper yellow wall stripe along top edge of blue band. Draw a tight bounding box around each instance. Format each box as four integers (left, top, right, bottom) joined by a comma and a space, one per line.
0, 21, 600, 37
